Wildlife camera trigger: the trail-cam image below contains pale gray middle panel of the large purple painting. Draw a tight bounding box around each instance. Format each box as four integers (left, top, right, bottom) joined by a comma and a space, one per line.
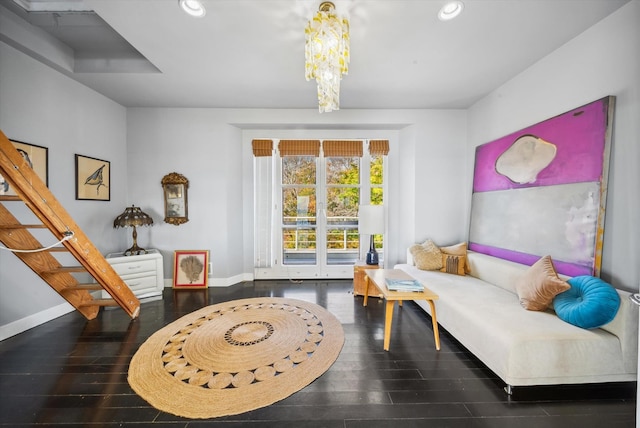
469, 182, 600, 262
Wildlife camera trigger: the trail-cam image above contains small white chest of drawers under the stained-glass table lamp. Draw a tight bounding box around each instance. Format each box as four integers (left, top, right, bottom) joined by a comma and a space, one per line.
102, 250, 164, 299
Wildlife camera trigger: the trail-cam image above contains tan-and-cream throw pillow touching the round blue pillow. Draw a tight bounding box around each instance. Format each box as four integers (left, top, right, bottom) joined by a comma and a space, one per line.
516, 256, 571, 311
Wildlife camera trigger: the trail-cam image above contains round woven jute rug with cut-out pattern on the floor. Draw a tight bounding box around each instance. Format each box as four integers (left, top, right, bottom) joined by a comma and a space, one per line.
128, 297, 344, 418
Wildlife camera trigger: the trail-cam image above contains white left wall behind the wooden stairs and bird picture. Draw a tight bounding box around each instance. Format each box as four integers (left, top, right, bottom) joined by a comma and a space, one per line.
0, 42, 127, 340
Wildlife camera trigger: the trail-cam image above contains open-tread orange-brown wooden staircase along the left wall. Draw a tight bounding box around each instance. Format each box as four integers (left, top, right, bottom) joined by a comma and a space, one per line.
0, 131, 140, 319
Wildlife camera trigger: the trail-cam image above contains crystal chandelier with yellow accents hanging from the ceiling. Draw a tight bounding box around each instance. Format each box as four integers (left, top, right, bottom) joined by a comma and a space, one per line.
305, 1, 349, 113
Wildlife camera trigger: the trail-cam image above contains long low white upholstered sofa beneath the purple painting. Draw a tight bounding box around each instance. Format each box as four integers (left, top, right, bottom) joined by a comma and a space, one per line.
395, 251, 638, 394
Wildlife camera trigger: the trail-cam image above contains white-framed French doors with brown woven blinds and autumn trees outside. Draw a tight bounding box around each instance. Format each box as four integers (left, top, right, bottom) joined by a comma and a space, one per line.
254, 140, 388, 278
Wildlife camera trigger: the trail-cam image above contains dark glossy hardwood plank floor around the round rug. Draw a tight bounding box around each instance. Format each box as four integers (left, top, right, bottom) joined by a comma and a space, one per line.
0, 280, 636, 428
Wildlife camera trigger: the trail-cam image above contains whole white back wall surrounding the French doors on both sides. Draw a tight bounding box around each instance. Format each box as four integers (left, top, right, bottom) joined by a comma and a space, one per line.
127, 108, 469, 286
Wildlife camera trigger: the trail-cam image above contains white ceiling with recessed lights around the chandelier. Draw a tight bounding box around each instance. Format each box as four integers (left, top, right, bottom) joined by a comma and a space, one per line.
0, 0, 629, 110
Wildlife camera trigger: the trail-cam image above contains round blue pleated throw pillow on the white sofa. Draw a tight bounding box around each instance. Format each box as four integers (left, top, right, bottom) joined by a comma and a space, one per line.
553, 275, 620, 329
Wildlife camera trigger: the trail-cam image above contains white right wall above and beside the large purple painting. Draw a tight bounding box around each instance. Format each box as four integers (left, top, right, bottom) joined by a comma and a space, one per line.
467, 0, 640, 291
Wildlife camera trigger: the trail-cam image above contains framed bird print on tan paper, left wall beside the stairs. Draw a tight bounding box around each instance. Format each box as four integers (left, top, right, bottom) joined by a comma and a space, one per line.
76, 155, 111, 201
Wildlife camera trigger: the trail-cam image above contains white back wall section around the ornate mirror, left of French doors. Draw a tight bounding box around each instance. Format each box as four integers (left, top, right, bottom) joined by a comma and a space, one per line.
127, 108, 243, 285
